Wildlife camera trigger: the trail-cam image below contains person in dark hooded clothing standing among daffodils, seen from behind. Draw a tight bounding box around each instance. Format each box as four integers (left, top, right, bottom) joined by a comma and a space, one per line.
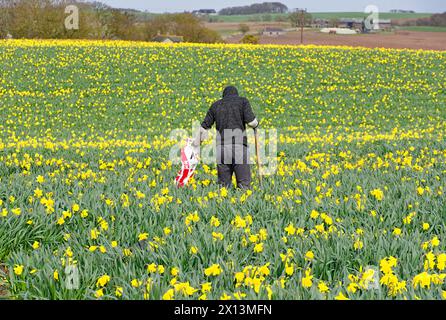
194, 86, 259, 189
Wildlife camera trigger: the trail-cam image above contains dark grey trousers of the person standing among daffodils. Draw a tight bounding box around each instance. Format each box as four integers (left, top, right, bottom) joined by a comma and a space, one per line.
217, 145, 251, 189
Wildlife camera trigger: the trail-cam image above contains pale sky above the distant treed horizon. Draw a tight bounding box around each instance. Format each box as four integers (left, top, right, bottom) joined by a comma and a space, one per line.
99, 0, 446, 13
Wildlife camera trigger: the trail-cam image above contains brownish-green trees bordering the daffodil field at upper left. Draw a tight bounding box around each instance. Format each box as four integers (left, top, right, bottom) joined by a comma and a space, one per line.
0, 0, 222, 43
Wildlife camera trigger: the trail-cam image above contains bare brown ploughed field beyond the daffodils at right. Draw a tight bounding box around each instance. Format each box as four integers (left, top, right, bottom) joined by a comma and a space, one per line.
226, 31, 446, 50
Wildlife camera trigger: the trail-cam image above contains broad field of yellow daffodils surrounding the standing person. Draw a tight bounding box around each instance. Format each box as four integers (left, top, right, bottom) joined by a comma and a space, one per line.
0, 40, 446, 299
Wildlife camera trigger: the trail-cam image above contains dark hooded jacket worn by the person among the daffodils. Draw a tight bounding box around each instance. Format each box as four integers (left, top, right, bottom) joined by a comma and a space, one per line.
201, 86, 256, 145
